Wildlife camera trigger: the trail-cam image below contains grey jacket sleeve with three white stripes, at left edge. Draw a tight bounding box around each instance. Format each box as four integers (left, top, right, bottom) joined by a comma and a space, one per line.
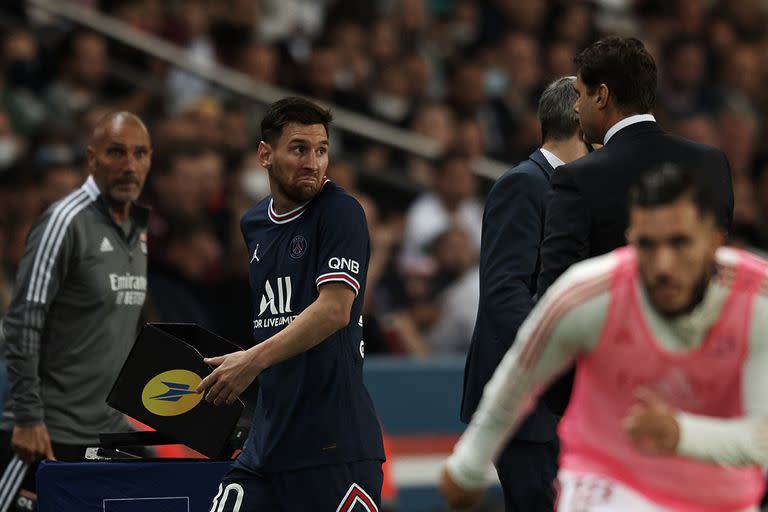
3, 211, 74, 425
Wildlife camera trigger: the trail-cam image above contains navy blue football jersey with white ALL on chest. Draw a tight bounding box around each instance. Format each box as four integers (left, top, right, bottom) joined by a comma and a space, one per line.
238, 181, 384, 471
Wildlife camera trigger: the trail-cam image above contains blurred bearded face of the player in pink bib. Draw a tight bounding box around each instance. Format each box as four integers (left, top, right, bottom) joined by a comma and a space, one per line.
627, 198, 724, 316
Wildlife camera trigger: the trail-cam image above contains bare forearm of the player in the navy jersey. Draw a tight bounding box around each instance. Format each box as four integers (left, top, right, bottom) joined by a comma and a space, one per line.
249, 299, 350, 369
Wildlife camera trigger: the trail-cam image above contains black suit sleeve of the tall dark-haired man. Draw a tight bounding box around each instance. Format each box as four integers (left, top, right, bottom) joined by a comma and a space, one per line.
536, 166, 592, 297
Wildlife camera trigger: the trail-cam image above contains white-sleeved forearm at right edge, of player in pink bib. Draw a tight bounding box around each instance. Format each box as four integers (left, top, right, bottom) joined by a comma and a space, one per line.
677, 412, 768, 466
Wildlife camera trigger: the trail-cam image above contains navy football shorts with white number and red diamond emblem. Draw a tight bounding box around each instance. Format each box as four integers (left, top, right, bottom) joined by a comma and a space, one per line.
210, 460, 383, 512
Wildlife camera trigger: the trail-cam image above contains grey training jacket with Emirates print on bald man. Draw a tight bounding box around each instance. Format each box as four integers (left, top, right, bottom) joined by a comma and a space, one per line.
0, 177, 148, 445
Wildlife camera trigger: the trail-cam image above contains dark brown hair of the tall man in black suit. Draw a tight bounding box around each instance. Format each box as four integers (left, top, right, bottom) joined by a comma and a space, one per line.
573, 36, 657, 114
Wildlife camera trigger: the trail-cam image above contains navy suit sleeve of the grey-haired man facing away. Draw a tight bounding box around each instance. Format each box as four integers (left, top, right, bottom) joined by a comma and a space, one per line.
481, 172, 549, 348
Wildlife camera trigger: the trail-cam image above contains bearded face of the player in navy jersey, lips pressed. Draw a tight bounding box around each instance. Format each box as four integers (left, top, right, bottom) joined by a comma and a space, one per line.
262, 123, 328, 204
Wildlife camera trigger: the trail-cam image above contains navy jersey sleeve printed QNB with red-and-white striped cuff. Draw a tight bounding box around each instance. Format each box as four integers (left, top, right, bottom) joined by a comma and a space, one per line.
315, 195, 370, 296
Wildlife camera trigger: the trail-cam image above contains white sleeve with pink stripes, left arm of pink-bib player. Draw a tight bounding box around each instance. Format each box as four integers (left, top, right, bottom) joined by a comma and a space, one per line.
446, 255, 610, 489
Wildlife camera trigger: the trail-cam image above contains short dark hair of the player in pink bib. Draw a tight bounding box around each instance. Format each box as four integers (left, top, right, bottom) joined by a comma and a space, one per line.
629, 163, 717, 219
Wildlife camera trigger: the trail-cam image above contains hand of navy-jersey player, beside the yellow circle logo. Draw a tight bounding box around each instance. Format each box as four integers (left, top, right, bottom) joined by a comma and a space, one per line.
196, 350, 260, 405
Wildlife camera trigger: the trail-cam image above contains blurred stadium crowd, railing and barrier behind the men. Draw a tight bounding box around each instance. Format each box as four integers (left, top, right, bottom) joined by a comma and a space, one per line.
0, 0, 768, 510
